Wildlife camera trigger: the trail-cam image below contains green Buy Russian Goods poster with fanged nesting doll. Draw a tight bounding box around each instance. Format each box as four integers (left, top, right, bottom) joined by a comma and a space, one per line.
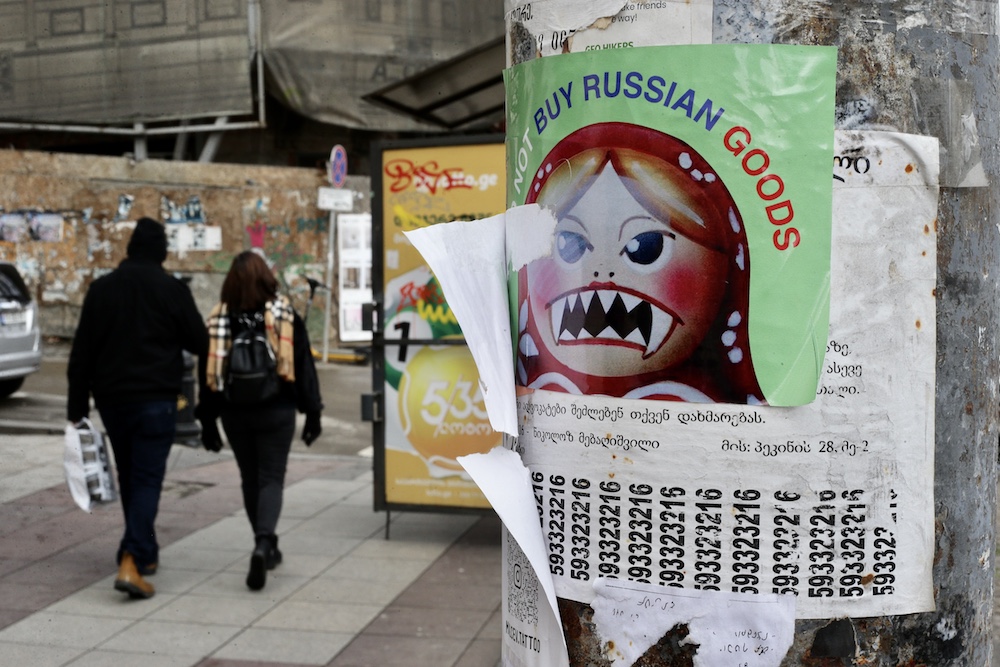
505, 45, 836, 406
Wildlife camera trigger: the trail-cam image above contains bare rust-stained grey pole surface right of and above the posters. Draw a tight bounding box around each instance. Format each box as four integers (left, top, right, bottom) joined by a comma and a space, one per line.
713, 0, 1000, 666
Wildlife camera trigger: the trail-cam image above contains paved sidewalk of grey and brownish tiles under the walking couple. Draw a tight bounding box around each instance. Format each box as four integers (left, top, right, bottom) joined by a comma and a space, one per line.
0, 435, 501, 667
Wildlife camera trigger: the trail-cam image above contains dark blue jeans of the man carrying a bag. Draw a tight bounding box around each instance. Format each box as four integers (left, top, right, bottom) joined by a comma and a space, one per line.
99, 401, 177, 570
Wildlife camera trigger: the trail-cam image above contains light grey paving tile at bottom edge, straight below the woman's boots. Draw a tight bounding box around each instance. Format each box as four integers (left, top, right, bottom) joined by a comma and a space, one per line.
211, 628, 352, 667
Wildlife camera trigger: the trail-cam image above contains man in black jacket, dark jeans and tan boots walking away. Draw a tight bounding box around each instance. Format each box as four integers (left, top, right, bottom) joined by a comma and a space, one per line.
66, 218, 208, 598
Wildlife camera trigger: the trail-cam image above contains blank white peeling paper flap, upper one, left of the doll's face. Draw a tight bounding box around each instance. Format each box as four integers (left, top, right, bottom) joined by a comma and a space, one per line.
405, 218, 517, 435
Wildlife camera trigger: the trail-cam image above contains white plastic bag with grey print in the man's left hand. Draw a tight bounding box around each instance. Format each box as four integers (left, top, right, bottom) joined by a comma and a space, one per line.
63, 419, 118, 512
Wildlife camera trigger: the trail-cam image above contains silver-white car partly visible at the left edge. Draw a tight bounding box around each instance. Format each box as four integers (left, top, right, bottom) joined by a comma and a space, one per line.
0, 262, 42, 398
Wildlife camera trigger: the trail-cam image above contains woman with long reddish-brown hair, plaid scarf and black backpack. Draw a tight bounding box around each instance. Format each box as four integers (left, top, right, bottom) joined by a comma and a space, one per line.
195, 251, 323, 590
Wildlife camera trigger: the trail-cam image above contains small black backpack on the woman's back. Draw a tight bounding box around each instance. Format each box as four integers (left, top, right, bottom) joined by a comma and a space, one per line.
223, 312, 281, 405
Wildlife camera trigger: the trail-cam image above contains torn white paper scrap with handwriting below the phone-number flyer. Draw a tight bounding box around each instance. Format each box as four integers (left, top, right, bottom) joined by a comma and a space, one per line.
593, 578, 795, 667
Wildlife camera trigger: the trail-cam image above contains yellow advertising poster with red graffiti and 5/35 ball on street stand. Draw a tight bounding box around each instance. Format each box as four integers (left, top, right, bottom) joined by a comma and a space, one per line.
380, 143, 505, 507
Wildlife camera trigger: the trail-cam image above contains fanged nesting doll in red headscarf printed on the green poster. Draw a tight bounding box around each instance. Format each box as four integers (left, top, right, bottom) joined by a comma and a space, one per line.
517, 123, 763, 403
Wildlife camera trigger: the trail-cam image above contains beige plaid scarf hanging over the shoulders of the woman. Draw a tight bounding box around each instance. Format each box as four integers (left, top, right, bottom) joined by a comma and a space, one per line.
205, 295, 295, 391
